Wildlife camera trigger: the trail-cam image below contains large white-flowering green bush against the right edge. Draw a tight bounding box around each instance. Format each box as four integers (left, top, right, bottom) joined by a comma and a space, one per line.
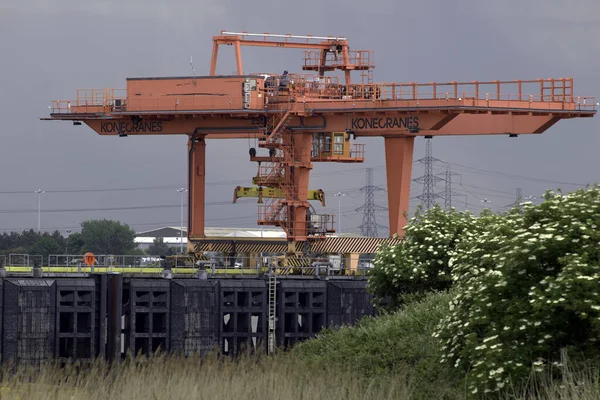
434, 186, 600, 396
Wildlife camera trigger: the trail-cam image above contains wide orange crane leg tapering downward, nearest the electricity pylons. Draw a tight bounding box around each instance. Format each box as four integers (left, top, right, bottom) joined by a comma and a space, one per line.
384, 137, 415, 237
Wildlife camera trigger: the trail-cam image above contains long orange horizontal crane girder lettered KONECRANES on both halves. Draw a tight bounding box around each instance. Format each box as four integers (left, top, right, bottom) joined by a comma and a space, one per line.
45, 109, 590, 139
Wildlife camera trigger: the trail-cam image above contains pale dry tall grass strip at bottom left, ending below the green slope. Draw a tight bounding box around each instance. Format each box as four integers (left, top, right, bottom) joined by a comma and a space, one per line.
0, 354, 410, 400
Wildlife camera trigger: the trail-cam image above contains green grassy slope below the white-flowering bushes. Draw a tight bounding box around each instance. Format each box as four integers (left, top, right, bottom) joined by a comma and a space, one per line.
292, 293, 459, 399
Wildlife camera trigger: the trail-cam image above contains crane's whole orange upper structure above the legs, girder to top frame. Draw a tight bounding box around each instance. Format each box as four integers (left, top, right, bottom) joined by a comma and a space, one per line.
49, 31, 597, 138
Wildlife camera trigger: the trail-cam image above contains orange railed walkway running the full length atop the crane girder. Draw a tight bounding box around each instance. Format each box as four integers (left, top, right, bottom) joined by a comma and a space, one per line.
50, 77, 597, 114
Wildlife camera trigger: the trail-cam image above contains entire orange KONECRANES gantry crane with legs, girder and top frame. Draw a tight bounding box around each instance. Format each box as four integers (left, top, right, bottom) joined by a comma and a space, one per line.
43, 31, 596, 256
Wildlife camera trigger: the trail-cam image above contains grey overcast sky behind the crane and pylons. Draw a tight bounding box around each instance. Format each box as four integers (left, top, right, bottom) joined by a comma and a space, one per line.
0, 0, 600, 234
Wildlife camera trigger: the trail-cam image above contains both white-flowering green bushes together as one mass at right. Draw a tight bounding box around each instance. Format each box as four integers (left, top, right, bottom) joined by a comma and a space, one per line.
370, 186, 600, 397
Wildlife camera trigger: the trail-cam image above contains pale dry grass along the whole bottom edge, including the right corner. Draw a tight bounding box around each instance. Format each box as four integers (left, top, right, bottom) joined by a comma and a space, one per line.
0, 348, 600, 400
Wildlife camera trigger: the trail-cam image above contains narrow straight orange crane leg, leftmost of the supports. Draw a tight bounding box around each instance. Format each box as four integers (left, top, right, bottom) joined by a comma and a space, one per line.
188, 133, 206, 239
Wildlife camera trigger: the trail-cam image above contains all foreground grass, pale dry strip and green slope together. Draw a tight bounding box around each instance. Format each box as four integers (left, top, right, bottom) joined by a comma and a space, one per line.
0, 293, 600, 400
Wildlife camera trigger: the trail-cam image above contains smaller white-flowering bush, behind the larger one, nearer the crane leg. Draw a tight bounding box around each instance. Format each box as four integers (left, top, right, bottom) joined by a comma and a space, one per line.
369, 206, 496, 309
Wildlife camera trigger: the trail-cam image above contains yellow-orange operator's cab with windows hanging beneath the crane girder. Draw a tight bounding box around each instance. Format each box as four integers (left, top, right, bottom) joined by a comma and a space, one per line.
312, 132, 365, 162
